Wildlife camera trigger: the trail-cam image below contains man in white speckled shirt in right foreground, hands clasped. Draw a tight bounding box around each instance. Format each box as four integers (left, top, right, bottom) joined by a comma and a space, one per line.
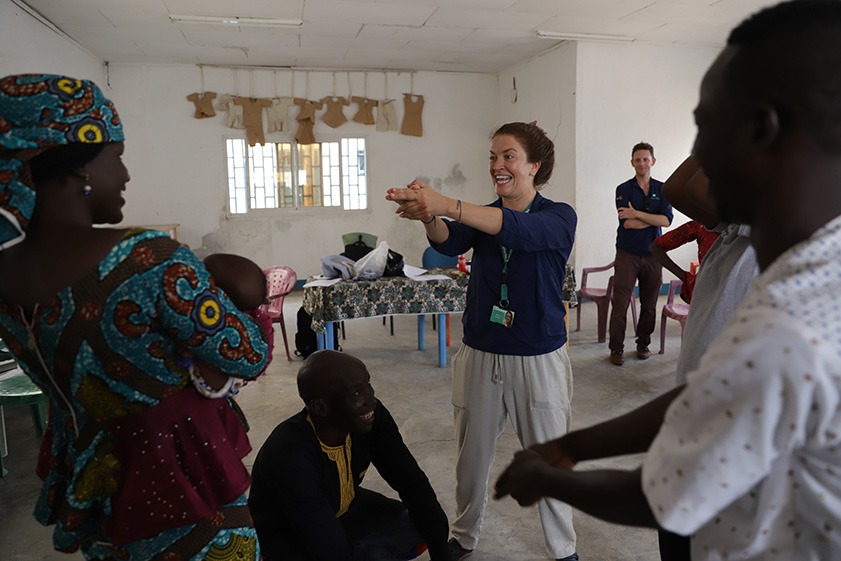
497, 0, 841, 561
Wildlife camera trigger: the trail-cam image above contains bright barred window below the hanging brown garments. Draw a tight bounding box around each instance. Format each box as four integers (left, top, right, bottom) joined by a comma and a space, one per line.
226, 138, 368, 214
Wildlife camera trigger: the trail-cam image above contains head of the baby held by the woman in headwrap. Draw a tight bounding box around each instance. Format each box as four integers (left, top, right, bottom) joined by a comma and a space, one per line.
204, 253, 267, 310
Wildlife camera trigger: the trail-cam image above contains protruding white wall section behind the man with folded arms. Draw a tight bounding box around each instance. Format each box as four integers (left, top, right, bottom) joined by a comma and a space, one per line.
497, 42, 717, 282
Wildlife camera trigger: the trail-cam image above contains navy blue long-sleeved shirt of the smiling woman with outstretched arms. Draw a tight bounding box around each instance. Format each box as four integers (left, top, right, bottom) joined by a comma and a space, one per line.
432, 193, 578, 356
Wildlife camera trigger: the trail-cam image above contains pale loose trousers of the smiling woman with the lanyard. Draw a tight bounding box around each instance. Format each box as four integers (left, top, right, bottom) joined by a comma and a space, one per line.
452, 345, 575, 558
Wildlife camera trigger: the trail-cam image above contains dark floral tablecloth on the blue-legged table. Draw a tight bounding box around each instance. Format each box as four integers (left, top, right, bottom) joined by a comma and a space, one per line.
304, 269, 468, 333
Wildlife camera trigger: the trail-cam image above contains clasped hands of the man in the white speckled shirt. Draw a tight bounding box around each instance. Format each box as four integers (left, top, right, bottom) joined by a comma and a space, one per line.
494, 440, 575, 506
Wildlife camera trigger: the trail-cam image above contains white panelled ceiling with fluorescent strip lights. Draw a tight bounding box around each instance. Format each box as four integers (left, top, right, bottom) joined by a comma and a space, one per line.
21, 0, 775, 73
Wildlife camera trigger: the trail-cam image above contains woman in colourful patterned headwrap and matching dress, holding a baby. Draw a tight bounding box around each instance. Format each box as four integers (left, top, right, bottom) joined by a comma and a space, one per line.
0, 75, 268, 561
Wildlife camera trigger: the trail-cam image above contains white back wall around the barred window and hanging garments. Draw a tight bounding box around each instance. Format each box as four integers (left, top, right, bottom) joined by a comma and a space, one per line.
111, 65, 496, 276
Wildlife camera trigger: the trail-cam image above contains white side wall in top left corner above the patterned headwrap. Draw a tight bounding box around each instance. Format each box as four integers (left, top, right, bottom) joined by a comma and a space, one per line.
0, 0, 102, 81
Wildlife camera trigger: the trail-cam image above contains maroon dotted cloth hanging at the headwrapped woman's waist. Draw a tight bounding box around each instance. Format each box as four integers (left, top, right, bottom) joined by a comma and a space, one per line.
109, 386, 251, 545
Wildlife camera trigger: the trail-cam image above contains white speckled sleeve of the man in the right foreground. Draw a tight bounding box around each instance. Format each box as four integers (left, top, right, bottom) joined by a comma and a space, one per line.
642, 310, 839, 535
